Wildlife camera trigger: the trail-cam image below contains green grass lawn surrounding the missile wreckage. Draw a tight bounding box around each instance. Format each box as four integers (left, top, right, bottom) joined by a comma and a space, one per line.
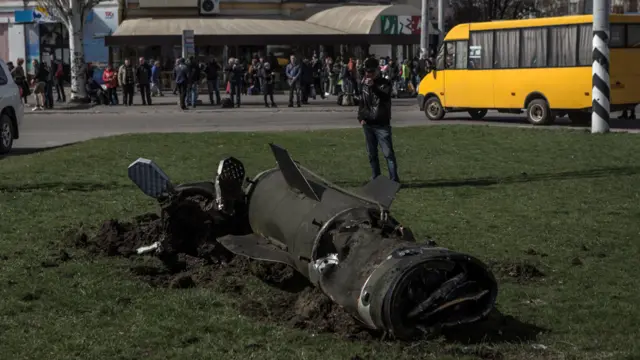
0, 126, 640, 360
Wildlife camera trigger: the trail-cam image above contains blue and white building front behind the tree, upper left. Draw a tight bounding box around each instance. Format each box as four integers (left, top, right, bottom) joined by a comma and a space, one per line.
0, 0, 119, 74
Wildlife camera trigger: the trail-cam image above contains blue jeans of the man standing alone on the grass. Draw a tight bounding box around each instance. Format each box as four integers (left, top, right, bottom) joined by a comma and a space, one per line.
362, 124, 400, 182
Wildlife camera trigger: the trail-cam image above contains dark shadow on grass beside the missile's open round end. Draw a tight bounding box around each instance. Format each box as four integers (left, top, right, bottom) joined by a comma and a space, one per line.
442, 309, 549, 344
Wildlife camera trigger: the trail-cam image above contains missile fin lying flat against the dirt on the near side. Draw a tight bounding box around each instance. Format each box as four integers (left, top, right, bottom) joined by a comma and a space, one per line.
218, 234, 296, 269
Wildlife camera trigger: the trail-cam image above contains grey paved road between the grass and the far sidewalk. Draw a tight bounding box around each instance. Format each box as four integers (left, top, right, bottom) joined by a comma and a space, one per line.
15, 106, 640, 153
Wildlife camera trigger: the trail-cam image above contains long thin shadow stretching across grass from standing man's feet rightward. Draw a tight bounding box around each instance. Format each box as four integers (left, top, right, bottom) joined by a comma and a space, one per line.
337, 166, 640, 189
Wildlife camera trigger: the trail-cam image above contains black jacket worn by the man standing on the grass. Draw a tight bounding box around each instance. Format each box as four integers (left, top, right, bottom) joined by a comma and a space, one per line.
358, 76, 391, 126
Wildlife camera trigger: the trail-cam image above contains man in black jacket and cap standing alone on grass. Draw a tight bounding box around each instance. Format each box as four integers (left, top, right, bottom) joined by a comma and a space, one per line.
358, 58, 400, 182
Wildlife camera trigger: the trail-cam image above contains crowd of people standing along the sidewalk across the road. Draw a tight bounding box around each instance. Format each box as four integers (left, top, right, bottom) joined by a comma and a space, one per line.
8, 53, 425, 111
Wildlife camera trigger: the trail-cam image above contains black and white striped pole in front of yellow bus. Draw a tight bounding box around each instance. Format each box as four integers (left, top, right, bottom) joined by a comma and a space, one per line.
591, 0, 611, 134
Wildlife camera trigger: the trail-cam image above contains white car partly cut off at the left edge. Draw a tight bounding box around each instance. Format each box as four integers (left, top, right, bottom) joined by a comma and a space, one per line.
0, 59, 24, 154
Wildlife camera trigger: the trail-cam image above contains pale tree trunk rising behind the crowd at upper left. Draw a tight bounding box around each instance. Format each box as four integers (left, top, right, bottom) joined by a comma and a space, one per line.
36, 0, 103, 101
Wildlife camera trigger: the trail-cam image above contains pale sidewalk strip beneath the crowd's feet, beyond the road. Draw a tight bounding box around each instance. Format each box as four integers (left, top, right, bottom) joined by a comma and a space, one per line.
25, 92, 418, 115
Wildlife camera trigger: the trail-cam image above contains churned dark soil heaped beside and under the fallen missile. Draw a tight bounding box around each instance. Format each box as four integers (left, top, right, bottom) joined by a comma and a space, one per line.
66, 197, 370, 339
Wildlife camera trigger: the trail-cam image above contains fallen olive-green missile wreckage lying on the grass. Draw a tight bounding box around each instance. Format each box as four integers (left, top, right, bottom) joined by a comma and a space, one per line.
128, 144, 498, 339
